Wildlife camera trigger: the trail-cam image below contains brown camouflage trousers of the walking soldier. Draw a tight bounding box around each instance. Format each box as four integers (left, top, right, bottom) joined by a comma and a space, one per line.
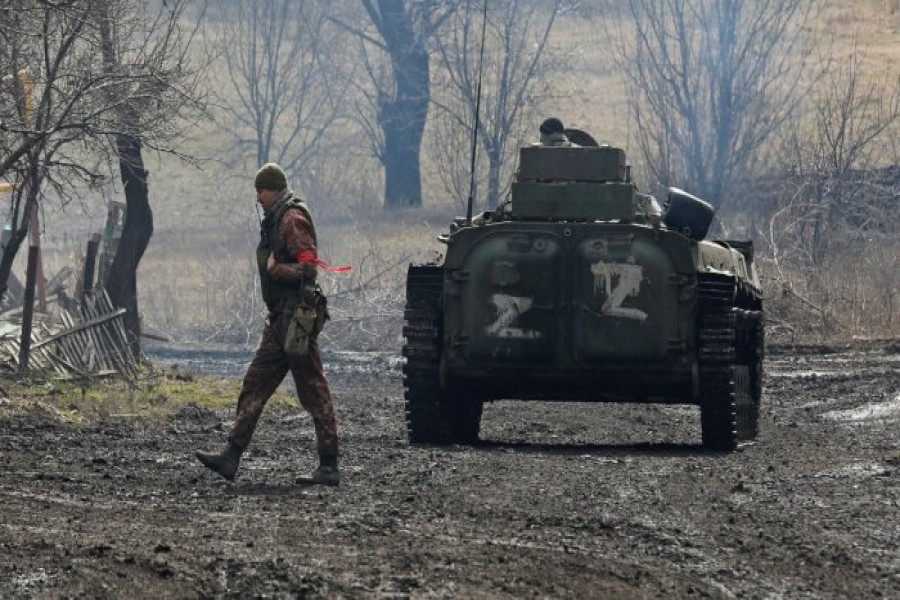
228, 314, 338, 457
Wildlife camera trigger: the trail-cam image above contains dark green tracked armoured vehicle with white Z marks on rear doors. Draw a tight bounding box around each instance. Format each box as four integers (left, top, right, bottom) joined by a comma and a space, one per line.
403, 136, 763, 451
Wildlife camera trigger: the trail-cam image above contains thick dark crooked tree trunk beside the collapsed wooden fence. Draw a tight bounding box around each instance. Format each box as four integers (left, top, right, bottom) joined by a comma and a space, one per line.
106, 109, 153, 358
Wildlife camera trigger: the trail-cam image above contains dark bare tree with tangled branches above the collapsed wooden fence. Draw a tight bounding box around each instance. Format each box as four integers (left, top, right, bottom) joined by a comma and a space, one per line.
0, 0, 204, 348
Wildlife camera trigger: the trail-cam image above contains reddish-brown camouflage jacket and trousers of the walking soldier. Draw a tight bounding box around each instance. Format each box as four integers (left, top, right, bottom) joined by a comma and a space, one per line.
228, 190, 338, 459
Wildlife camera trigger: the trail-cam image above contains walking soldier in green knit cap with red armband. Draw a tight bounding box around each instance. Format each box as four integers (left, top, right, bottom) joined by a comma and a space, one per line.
196, 163, 340, 485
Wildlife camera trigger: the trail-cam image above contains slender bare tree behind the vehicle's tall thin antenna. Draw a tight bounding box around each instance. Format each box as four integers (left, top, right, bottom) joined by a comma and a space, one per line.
432, 0, 563, 207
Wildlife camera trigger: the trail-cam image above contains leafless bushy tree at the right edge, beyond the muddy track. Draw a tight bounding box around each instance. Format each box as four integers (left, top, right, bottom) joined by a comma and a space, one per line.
765, 52, 900, 335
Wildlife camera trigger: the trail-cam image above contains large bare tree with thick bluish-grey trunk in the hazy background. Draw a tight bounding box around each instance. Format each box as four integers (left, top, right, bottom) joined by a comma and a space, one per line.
336, 0, 456, 209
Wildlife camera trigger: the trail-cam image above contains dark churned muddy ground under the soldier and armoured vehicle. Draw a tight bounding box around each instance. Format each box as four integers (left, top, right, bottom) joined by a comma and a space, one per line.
0, 342, 900, 598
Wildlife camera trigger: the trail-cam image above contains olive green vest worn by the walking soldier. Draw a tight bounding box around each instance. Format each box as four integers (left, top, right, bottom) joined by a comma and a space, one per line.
256, 192, 318, 312
